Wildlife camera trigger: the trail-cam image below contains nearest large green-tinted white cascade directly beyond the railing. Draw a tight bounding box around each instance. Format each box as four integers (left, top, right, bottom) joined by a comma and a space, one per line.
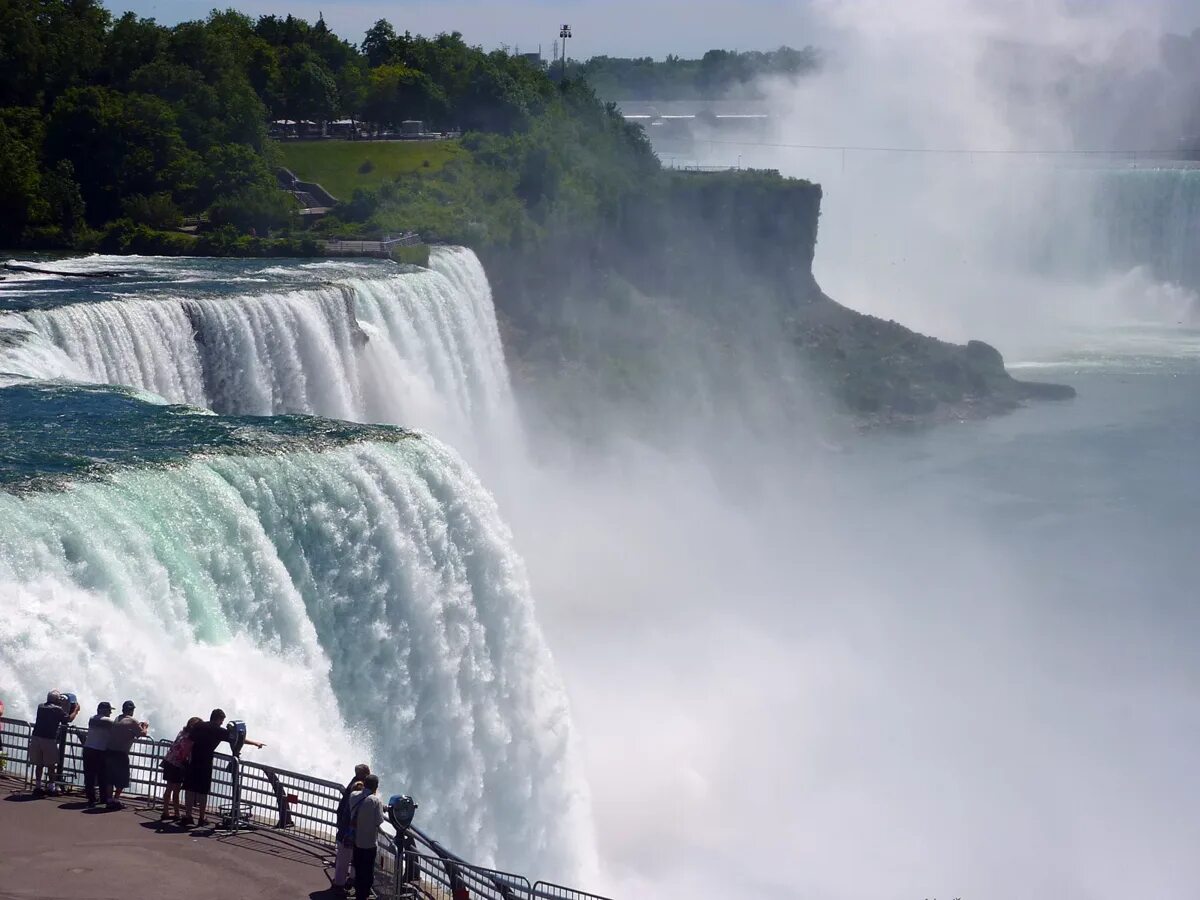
0, 438, 593, 877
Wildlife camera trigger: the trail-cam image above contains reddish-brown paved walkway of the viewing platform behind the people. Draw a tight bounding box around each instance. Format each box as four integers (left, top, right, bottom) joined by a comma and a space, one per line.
0, 778, 340, 900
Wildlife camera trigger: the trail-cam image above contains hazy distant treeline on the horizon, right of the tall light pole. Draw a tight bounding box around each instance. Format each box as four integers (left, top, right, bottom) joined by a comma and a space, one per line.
566, 47, 821, 101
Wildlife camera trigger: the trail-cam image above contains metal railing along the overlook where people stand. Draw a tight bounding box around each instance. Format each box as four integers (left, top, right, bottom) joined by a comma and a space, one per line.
0, 718, 606, 900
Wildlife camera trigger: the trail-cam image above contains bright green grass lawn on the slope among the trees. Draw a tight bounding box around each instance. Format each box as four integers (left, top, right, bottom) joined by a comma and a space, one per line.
280, 140, 467, 200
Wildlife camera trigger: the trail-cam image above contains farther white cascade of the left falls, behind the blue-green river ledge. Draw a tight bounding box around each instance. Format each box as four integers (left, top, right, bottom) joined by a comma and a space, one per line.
0, 247, 515, 455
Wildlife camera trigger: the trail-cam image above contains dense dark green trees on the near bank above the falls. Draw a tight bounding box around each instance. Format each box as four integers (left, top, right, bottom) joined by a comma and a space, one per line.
0, 0, 566, 247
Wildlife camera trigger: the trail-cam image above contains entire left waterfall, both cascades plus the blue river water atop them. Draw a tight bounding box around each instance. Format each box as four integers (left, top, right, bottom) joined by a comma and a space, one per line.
0, 248, 595, 880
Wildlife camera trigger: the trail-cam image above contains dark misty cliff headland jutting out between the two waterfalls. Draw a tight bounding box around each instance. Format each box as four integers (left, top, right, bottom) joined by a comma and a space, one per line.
472, 172, 1074, 425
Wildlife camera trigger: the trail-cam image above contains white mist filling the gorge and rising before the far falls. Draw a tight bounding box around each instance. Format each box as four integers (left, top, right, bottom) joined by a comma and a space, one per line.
502, 1, 1200, 900
